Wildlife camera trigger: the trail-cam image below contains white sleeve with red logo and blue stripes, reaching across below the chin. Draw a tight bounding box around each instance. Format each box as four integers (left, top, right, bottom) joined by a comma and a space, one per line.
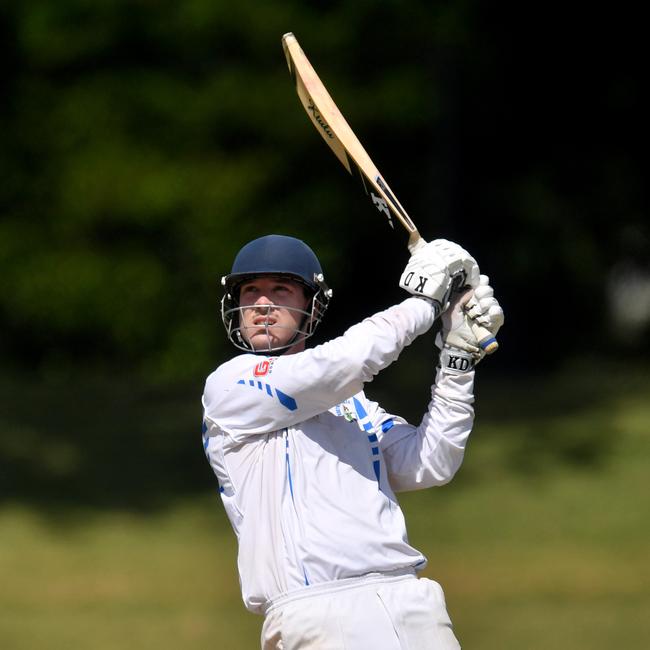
203, 298, 435, 437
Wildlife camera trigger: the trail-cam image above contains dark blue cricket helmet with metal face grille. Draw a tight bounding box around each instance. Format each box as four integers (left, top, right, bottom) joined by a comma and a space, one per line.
221, 235, 332, 353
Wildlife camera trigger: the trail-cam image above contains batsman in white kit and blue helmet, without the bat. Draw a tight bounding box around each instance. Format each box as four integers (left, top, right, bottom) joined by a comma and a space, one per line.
202, 230, 503, 650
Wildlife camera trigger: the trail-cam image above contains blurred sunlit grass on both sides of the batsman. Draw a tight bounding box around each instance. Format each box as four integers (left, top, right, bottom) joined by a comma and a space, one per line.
0, 362, 650, 650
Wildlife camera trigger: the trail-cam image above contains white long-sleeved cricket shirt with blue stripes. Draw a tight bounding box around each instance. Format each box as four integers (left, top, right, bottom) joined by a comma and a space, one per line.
203, 298, 474, 613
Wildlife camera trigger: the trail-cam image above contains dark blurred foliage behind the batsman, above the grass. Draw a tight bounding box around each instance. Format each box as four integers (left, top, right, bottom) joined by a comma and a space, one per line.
0, 0, 650, 506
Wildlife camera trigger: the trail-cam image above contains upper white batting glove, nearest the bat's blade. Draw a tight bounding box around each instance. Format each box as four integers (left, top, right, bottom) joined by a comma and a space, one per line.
399, 239, 479, 312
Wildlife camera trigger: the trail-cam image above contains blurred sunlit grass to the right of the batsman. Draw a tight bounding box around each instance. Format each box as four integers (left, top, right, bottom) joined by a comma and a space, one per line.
401, 368, 650, 650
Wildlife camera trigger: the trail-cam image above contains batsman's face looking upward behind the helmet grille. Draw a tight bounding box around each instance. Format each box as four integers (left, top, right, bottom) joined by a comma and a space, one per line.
239, 277, 309, 352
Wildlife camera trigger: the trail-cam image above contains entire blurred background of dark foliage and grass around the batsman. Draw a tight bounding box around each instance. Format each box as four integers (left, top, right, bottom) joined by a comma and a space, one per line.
0, 0, 650, 650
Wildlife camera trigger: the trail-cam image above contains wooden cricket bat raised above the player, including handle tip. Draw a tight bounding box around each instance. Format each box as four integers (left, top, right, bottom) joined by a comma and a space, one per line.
282, 32, 499, 354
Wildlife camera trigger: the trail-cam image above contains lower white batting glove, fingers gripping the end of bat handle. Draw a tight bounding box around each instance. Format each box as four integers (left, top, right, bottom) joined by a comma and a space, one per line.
436, 275, 504, 374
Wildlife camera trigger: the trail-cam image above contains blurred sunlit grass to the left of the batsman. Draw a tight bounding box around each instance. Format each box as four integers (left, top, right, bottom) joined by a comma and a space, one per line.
0, 497, 258, 650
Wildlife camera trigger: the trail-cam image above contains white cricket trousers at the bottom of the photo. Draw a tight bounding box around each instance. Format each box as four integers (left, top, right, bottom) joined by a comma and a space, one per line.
262, 573, 460, 650
